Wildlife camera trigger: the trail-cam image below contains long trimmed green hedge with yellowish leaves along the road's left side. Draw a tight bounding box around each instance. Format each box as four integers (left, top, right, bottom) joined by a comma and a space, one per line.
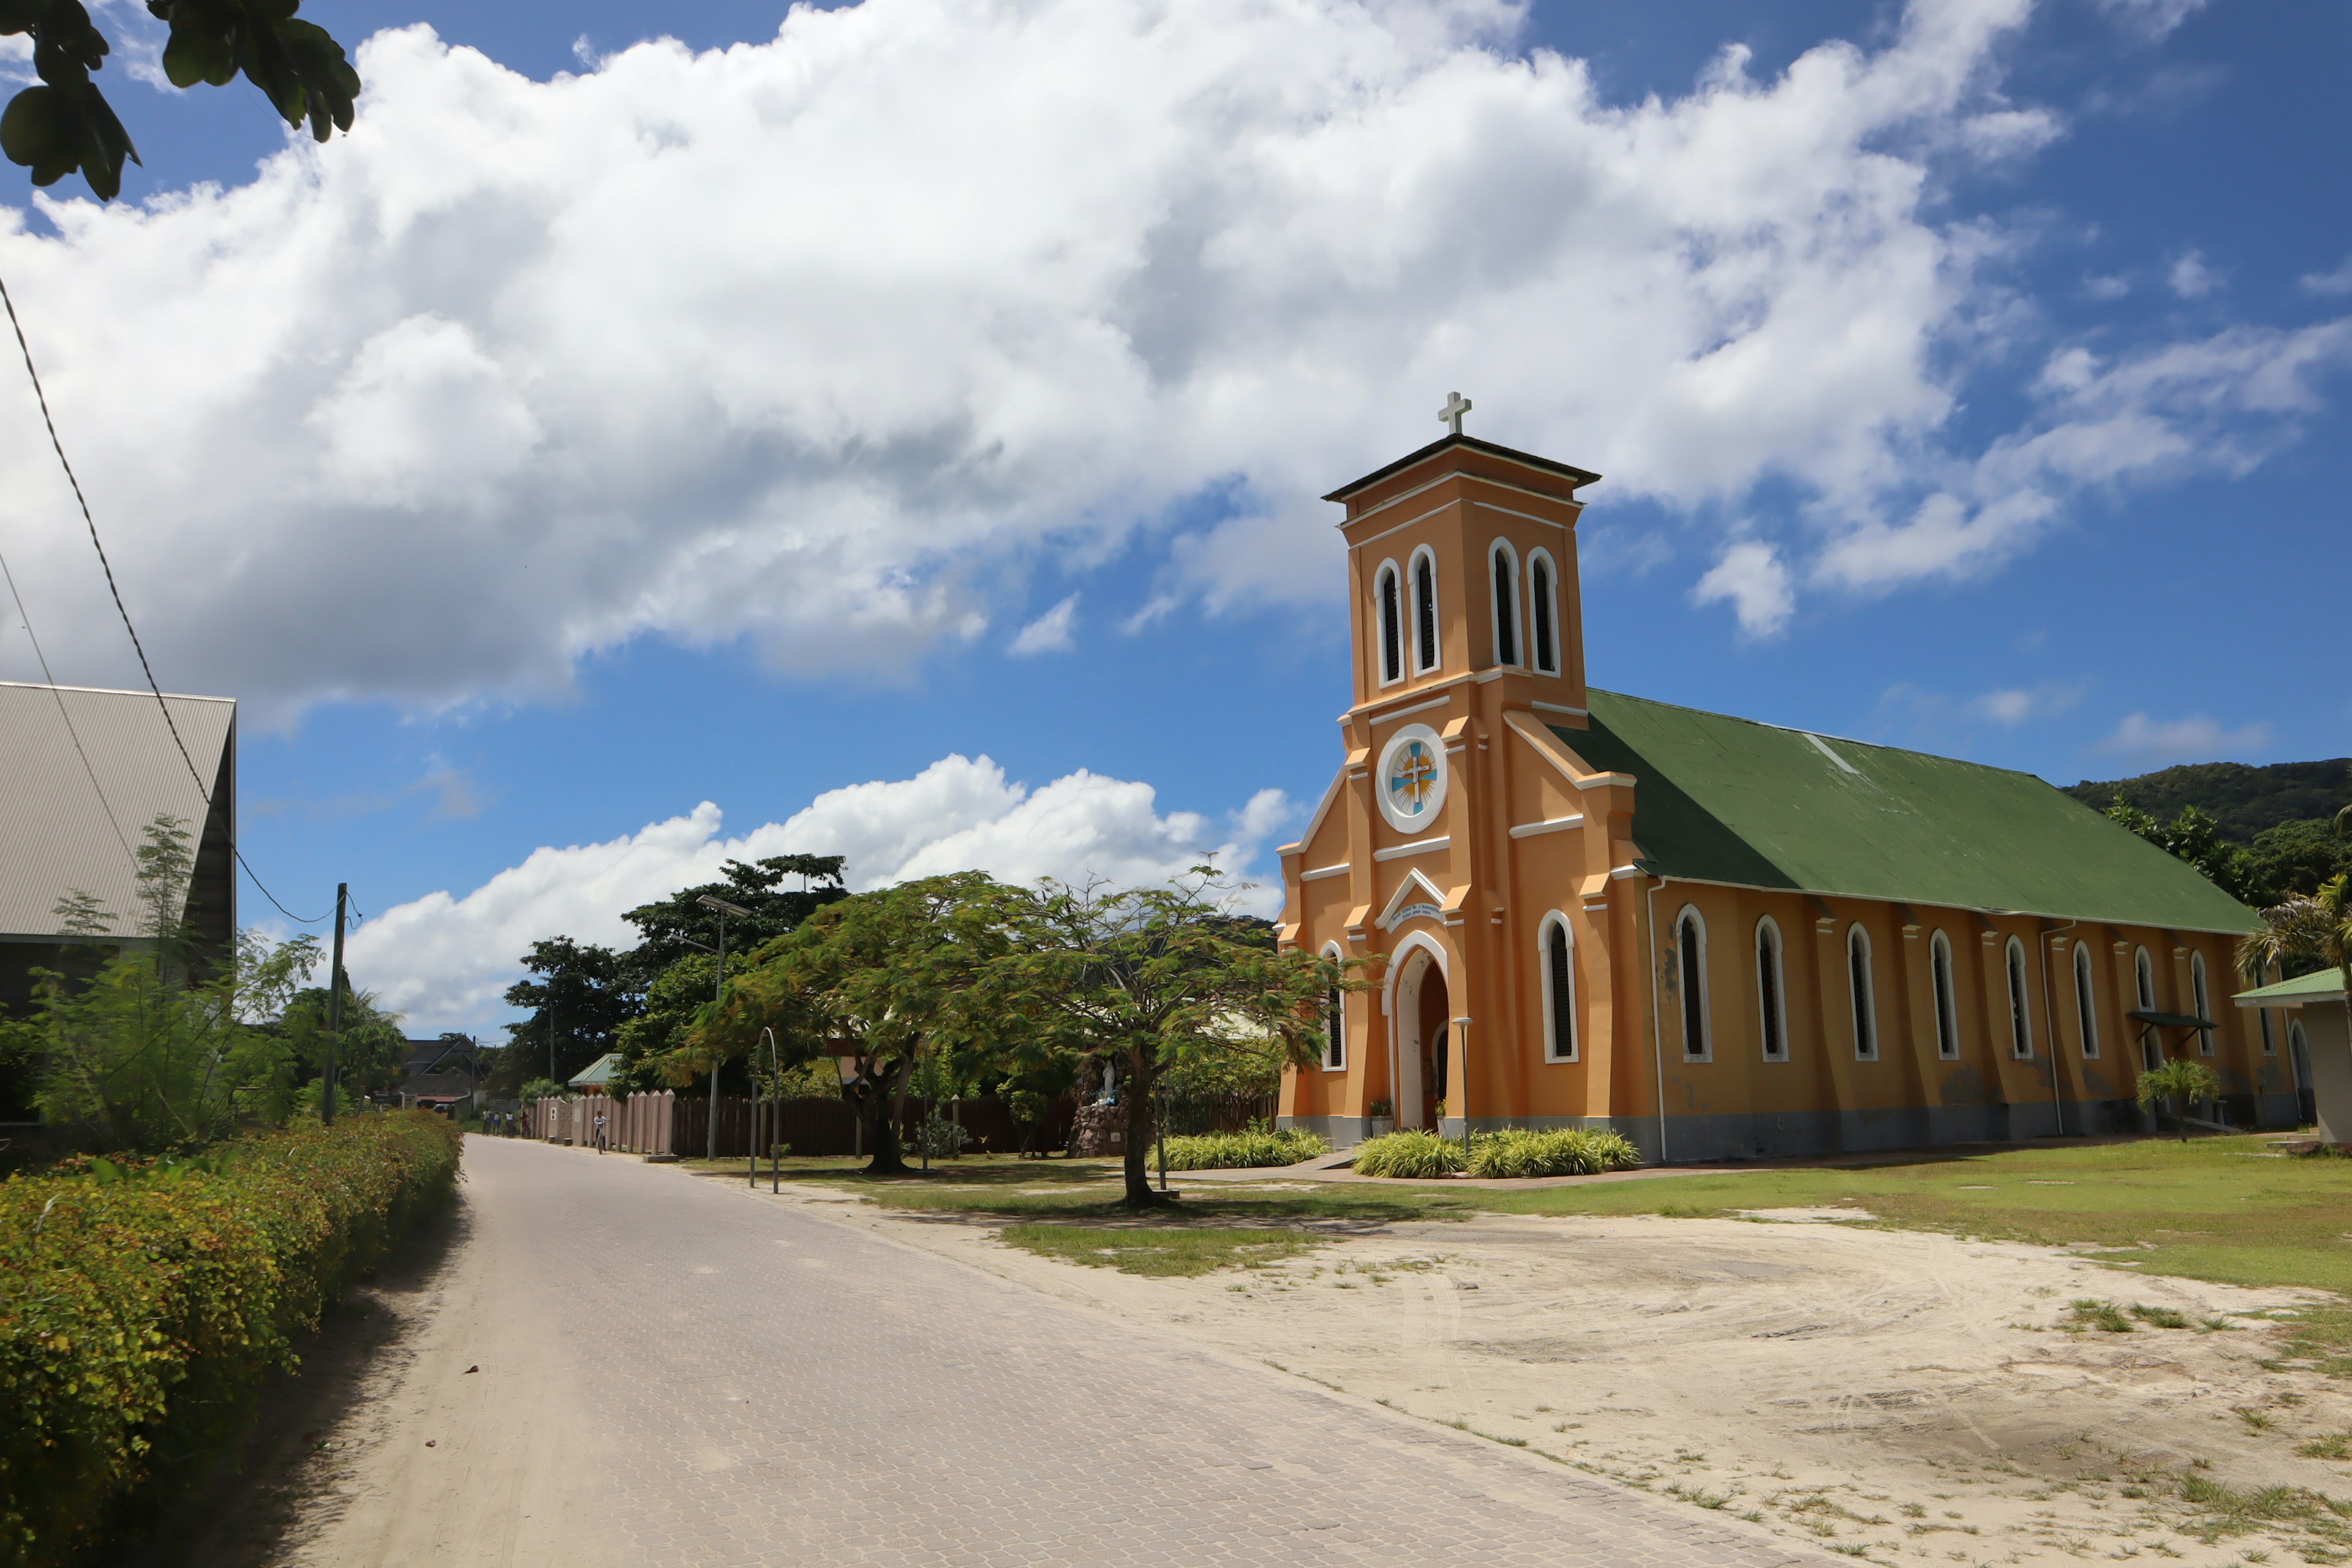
0, 1112, 461, 1568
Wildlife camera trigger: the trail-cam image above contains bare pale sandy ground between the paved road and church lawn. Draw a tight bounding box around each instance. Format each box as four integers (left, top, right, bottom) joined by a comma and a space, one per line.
769, 1189, 2352, 1566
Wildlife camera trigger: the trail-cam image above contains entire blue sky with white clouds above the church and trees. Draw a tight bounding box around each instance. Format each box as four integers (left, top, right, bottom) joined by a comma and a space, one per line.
0, 0, 2352, 1027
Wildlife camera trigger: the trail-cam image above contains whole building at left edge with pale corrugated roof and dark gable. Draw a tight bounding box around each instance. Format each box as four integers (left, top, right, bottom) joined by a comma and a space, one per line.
0, 682, 238, 1121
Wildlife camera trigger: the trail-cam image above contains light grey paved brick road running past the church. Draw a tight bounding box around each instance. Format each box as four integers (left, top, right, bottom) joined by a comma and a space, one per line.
423, 1138, 1834, 1568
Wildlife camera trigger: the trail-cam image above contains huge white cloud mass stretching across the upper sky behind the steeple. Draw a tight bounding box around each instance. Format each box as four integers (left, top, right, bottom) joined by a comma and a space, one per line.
0, 0, 2333, 722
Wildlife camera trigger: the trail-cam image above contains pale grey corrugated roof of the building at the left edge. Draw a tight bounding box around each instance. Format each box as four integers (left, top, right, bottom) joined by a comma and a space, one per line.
0, 682, 238, 936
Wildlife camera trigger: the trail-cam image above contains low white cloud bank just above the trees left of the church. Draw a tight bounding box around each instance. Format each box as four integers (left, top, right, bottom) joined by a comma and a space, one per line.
348, 755, 1296, 1032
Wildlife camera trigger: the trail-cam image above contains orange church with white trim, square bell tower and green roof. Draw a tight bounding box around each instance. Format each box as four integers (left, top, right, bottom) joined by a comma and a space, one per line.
1280, 421, 2296, 1164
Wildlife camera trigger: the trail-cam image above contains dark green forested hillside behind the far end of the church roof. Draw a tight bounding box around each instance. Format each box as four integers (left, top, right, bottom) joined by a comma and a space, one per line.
2067, 757, 2352, 910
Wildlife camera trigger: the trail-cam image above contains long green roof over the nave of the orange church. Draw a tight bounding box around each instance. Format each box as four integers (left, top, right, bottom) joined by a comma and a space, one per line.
1552, 691, 2263, 931
